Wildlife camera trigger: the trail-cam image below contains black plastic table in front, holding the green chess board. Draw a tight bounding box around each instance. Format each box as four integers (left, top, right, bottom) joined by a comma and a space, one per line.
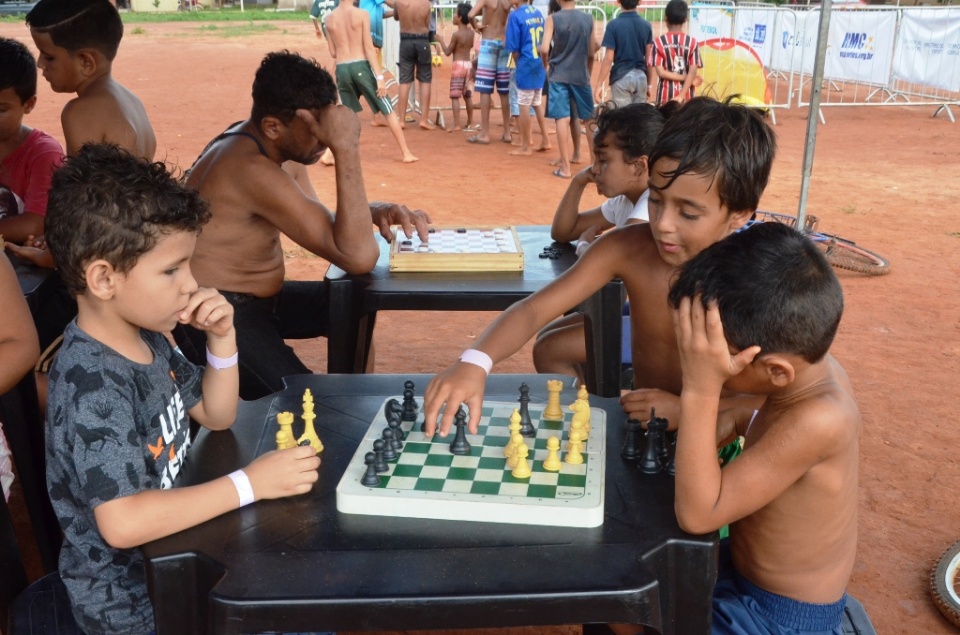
144, 375, 717, 635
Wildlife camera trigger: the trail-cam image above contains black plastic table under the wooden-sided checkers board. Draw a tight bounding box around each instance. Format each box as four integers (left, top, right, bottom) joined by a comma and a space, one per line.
326, 225, 623, 397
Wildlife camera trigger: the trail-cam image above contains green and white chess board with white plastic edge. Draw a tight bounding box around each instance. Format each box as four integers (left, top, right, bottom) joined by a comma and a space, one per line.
337, 397, 606, 527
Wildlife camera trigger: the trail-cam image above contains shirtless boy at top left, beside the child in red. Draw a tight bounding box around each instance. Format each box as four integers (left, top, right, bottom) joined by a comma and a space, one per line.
27, 0, 157, 161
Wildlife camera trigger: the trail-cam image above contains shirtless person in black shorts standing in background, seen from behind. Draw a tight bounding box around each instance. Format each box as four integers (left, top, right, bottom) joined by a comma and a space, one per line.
394, 0, 436, 130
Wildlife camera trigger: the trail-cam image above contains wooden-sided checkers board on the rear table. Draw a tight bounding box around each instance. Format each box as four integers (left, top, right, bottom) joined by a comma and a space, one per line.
390, 226, 523, 272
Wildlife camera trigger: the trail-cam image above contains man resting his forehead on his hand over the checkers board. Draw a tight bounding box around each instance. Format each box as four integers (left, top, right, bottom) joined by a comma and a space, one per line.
174, 52, 429, 399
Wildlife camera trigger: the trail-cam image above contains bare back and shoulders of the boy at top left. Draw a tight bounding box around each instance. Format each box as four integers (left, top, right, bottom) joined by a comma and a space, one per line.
60, 75, 157, 161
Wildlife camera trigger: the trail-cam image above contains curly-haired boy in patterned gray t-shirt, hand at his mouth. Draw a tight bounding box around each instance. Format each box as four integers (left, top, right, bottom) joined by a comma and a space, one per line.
46, 144, 320, 635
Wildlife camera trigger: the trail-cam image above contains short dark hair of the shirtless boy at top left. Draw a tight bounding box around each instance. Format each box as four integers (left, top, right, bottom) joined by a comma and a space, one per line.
27, 0, 123, 60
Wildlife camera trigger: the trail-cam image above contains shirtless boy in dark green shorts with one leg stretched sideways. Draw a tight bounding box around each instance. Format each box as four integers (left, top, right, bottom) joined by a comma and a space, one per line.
325, 2, 417, 163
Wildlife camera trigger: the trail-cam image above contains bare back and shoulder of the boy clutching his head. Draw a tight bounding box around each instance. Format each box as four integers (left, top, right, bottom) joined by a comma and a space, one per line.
724, 355, 861, 604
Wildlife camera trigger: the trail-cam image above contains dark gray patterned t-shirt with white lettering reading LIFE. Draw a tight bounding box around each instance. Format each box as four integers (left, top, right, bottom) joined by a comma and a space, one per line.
46, 321, 203, 635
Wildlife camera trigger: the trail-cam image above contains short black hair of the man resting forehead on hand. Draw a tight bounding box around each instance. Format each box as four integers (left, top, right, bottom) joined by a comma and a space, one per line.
250, 51, 337, 124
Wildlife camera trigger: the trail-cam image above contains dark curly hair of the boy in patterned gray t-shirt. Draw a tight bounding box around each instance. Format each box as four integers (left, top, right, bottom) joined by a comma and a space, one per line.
45, 143, 210, 296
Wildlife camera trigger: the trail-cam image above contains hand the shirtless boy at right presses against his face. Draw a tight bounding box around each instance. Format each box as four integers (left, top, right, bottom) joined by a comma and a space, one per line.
673, 295, 760, 396
